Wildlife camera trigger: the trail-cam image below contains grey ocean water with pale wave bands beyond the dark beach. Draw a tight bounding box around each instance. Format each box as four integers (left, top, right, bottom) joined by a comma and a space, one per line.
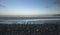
0, 17, 60, 24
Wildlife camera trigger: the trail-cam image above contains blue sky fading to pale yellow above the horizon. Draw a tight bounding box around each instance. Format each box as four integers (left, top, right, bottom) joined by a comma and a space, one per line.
0, 0, 60, 16
